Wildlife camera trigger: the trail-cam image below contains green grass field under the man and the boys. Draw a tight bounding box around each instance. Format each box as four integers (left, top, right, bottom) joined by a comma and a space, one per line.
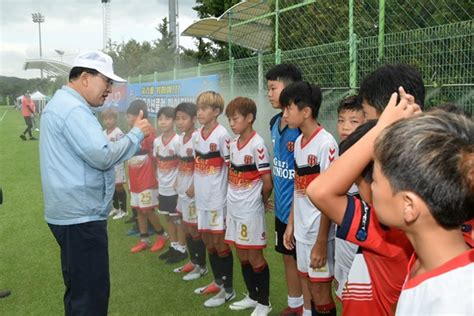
0, 106, 287, 316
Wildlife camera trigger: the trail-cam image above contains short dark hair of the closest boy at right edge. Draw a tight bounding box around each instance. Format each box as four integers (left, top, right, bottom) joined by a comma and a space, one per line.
374, 111, 474, 229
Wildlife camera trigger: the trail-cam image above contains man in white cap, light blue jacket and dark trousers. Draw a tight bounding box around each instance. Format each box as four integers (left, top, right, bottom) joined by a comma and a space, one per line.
40, 51, 151, 315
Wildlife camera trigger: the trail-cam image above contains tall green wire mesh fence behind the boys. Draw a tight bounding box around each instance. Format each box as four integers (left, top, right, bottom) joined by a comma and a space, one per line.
130, 0, 474, 138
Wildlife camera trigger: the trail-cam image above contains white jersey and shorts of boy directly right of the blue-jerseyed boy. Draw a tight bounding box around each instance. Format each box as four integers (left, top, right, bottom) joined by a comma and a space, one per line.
294, 127, 338, 245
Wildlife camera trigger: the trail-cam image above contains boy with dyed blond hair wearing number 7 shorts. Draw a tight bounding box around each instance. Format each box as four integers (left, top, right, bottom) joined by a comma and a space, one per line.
194, 91, 235, 307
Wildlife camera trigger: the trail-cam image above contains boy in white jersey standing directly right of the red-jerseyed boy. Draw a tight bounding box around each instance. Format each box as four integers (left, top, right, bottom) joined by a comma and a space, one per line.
153, 106, 188, 264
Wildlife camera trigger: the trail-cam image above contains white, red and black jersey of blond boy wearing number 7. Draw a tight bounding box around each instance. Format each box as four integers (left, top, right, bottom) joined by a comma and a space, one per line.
194, 124, 230, 210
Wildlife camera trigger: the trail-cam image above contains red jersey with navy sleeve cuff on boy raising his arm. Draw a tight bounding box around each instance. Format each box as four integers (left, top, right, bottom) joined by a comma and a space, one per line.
337, 196, 413, 315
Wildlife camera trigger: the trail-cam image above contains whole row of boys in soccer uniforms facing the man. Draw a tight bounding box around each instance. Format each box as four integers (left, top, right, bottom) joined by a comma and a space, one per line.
102, 64, 474, 315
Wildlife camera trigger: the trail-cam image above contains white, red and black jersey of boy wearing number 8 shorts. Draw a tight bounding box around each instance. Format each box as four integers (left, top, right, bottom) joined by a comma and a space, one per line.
227, 131, 271, 220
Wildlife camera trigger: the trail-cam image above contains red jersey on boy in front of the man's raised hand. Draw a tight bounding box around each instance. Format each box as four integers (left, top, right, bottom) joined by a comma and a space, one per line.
128, 128, 158, 193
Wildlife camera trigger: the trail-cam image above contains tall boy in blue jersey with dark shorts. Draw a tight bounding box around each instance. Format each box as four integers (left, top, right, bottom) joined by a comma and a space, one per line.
266, 64, 307, 315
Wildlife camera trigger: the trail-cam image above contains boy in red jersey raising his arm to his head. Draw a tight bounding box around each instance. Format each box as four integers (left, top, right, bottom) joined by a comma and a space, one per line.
306, 90, 415, 315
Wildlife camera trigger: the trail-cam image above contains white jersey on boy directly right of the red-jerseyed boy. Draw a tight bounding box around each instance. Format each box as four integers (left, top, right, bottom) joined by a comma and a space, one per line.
153, 133, 179, 196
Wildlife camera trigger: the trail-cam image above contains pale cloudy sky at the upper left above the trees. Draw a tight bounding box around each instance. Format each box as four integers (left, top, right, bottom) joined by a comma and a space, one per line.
0, 0, 198, 78
